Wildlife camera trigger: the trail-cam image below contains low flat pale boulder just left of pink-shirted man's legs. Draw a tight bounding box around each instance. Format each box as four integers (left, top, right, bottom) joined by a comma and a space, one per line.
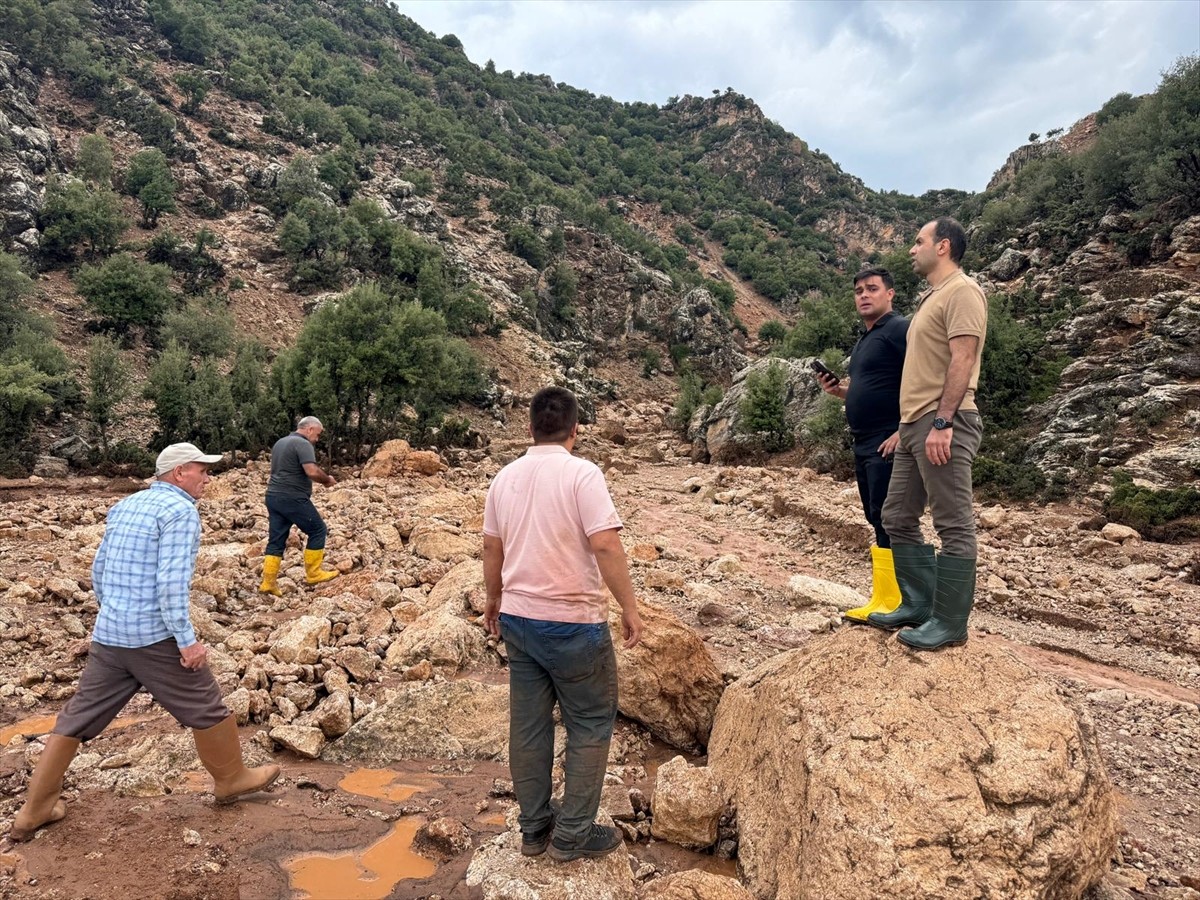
324, 680, 509, 766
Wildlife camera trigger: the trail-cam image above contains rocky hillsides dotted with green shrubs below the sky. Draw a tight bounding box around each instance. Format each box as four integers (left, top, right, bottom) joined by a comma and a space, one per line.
0, 0, 1200, 513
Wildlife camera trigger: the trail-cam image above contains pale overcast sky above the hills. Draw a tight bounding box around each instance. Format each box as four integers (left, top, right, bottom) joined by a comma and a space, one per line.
392, 0, 1200, 193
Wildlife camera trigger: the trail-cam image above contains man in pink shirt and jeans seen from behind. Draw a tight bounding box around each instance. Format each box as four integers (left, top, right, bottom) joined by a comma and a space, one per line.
484, 388, 642, 862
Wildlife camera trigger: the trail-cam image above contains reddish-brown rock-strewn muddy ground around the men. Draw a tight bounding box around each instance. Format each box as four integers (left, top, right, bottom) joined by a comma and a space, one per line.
0, 403, 1200, 900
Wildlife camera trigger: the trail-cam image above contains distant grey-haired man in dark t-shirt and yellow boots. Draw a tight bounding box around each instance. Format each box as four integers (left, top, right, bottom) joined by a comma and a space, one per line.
258, 415, 337, 596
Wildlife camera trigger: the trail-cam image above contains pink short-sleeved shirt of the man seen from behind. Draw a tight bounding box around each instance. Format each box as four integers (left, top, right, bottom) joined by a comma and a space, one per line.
484, 444, 622, 623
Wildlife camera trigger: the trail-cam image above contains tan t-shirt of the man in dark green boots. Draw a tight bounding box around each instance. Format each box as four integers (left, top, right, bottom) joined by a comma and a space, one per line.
900, 269, 988, 424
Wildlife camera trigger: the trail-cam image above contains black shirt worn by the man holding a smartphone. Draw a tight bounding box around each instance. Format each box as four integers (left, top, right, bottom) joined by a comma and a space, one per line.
846, 312, 908, 436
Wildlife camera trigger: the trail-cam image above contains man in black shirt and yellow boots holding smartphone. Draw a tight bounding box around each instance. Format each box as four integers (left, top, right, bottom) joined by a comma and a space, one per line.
812, 269, 908, 623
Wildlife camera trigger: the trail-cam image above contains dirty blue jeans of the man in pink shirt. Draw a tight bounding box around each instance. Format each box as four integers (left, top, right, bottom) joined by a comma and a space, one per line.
500, 614, 617, 844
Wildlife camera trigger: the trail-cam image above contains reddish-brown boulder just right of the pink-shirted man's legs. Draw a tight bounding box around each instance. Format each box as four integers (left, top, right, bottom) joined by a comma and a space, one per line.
608, 600, 725, 752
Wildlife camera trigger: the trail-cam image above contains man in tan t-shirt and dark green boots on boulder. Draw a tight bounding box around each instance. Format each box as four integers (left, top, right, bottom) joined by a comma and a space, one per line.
868, 217, 988, 650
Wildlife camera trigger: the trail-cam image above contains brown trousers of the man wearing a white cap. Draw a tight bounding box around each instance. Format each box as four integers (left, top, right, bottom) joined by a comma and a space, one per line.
54, 638, 229, 740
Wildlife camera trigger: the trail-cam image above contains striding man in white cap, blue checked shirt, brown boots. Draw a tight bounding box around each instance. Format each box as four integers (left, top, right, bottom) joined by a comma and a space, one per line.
10, 444, 280, 841
